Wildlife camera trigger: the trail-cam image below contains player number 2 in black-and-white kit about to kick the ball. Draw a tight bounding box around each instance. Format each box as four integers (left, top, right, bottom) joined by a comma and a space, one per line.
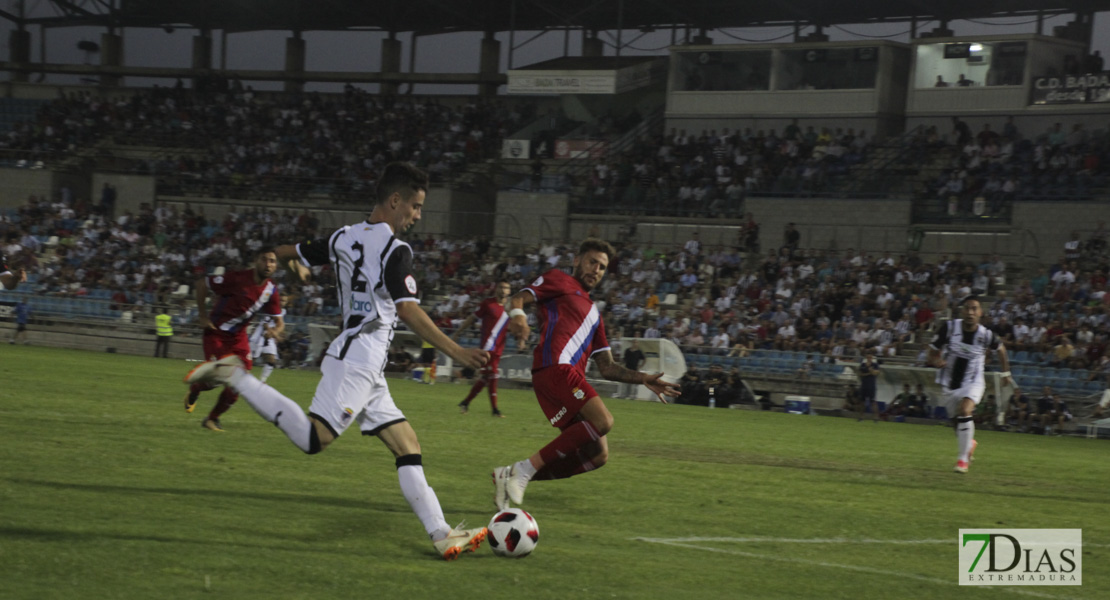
186, 163, 488, 560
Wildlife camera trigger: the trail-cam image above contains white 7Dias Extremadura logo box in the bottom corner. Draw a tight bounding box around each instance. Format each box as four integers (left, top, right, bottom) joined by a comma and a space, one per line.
959, 529, 1083, 586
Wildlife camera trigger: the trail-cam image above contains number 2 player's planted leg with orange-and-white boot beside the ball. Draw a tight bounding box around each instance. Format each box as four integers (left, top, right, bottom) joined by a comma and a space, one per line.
370, 397, 486, 560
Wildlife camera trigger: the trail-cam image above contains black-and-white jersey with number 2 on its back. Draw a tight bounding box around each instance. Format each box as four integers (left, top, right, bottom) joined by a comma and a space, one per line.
296, 222, 420, 367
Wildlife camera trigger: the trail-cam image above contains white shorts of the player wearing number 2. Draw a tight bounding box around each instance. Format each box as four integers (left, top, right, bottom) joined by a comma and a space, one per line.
309, 356, 406, 436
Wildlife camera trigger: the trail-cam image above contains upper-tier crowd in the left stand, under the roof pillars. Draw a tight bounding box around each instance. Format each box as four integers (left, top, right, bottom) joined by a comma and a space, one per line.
0, 84, 535, 200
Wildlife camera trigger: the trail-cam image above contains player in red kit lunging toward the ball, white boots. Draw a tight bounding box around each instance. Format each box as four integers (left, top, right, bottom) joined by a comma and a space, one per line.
493, 240, 680, 510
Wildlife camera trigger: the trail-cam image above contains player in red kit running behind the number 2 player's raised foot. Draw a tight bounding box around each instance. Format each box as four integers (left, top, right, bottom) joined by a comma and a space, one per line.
185, 247, 285, 431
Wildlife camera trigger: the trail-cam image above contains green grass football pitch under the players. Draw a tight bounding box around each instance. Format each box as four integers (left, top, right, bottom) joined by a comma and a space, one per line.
0, 344, 1110, 599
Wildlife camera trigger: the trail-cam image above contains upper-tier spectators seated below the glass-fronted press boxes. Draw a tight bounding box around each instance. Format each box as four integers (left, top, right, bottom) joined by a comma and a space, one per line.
581, 120, 871, 216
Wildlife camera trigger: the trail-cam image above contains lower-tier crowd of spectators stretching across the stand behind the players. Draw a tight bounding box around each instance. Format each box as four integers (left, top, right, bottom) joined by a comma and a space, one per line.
0, 182, 1110, 401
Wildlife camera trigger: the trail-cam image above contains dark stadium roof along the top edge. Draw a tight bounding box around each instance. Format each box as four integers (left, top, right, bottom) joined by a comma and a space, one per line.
0, 0, 1110, 33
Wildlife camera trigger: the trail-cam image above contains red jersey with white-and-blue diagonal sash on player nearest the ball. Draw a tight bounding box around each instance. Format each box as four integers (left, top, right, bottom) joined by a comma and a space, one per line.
524, 268, 609, 374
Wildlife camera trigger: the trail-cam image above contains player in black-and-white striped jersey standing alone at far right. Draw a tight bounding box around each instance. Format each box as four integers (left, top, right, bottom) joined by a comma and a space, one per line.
928, 295, 1012, 472
